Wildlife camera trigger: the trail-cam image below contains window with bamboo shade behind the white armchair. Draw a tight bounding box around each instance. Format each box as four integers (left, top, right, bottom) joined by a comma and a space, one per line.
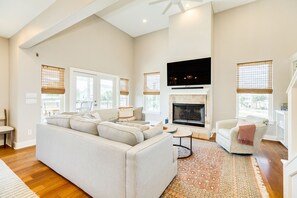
237, 61, 273, 119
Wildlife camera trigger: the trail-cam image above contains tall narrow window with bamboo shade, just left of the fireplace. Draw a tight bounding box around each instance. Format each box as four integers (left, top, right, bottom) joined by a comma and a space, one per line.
143, 72, 160, 113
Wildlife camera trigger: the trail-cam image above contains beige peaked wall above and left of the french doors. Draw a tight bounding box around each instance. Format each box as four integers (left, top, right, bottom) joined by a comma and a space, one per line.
11, 16, 133, 148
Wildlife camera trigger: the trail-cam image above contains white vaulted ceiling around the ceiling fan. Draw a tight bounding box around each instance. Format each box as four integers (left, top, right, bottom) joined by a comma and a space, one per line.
97, 0, 256, 37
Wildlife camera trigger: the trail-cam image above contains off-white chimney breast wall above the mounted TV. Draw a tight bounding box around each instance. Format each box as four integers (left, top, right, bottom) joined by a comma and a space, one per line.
169, 3, 213, 62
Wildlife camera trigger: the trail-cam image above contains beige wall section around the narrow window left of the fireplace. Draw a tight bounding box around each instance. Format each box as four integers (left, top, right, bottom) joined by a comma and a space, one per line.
133, 29, 169, 121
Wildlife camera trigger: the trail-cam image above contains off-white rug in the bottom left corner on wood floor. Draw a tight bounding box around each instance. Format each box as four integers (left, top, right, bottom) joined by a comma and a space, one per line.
0, 160, 38, 198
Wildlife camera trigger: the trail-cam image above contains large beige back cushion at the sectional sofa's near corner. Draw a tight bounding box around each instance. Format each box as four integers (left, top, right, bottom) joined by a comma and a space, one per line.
98, 122, 144, 146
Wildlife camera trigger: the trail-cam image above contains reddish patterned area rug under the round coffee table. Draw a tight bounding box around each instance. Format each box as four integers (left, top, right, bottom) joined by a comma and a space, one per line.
161, 139, 269, 198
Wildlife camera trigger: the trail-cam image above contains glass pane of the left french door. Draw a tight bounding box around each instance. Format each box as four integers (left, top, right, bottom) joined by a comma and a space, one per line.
75, 72, 97, 112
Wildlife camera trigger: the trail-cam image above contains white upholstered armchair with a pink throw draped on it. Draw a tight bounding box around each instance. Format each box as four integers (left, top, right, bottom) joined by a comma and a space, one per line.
216, 116, 268, 154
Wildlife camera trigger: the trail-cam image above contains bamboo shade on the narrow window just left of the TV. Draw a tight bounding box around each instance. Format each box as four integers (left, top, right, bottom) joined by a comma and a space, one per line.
143, 72, 160, 95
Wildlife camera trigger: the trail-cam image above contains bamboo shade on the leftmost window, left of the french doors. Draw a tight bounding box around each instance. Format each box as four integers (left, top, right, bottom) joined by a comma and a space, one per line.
41, 65, 65, 94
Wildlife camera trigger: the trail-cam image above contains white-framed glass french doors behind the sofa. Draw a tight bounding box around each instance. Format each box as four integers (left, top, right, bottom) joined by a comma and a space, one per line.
70, 69, 118, 112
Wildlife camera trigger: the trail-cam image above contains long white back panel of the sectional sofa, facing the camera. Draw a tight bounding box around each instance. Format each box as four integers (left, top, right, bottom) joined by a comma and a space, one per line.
36, 124, 131, 198
